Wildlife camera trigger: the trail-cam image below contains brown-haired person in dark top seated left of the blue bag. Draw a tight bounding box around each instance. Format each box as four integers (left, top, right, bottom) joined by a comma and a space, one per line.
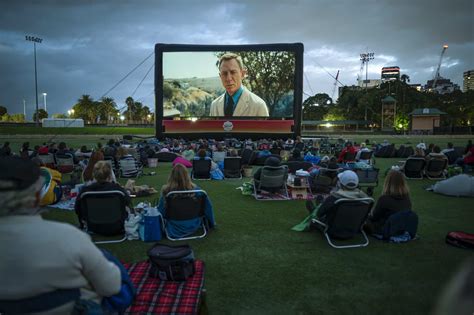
74, 161, 133, 228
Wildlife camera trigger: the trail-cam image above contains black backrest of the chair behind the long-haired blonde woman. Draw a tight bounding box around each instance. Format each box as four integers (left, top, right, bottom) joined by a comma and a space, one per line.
165, 190, 207, 221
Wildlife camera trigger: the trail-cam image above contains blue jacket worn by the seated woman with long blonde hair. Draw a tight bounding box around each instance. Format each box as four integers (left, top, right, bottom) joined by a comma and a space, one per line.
158, 187, 216, 238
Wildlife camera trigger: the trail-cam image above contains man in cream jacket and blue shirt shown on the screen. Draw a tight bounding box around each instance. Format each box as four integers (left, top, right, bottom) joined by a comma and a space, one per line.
209, 53, 268, 117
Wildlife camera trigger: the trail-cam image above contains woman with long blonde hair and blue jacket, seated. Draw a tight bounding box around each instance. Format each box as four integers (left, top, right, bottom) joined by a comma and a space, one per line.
158, 164, 215, 237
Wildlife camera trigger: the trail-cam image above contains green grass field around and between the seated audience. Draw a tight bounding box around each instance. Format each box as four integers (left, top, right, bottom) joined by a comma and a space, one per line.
0, 132, 474, 314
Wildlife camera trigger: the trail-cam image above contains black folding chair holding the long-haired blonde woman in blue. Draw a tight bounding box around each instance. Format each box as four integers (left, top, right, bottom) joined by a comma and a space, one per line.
163, 190, 209, 241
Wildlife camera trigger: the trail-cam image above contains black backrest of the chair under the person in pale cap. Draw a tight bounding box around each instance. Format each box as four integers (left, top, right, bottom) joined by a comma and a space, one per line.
327, 198, 374, 239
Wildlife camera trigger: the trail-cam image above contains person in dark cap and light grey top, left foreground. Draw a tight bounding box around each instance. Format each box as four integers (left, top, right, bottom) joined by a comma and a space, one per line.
0, 157, 121, 314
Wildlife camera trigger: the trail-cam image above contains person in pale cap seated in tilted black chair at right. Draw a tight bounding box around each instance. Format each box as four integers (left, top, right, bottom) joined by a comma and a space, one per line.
307, 170, 367, 222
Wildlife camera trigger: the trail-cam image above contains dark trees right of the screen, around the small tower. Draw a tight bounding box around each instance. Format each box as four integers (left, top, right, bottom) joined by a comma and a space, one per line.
303, 80, 474, 129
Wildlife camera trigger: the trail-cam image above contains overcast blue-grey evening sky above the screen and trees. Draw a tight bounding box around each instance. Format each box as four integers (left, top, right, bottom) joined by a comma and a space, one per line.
0, 0, 474, 119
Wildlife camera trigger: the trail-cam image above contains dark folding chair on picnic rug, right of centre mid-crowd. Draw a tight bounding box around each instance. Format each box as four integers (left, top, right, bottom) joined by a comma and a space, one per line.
253, 165, 290, 200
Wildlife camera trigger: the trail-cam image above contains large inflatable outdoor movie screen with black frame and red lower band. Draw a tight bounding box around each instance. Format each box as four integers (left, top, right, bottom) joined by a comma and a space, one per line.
155, 43, 303, 137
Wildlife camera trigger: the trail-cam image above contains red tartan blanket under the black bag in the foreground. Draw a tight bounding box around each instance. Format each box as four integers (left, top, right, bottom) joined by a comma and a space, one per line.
125, 260, 204, 314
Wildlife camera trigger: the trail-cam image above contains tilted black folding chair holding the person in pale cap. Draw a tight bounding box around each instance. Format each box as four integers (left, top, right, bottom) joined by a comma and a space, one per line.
312, 198, 374, 249
